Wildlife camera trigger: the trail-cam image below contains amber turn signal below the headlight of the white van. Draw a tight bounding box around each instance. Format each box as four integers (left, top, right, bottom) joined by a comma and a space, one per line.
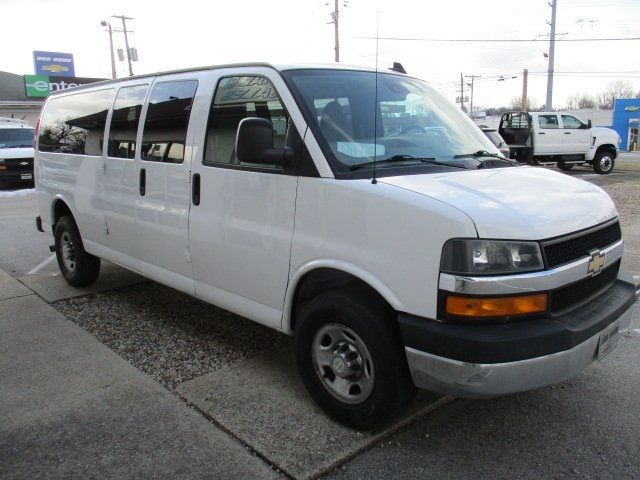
446, 293, 547, 317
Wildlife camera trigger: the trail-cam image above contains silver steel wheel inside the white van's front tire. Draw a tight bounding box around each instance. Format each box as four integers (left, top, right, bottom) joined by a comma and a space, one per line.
312, 323, 374, 403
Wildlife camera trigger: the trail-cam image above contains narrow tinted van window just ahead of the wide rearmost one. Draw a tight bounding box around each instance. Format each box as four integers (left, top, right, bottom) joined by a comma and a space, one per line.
107, 85, 149, 158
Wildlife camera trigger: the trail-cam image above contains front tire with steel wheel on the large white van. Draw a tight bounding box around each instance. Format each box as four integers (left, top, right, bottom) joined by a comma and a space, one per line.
295, 291, 416, 430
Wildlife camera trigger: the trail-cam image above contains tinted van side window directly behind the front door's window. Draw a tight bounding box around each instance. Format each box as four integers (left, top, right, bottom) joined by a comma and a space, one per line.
140, 80, 198, 163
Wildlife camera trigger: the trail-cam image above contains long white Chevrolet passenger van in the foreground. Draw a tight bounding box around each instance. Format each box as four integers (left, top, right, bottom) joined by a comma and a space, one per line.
35, 64, 636, 428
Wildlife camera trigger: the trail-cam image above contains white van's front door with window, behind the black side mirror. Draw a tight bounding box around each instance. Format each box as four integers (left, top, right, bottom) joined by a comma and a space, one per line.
189, 67, 302, 328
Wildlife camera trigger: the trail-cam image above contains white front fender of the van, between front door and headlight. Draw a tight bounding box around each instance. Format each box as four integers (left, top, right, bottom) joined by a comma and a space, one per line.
283, 177, 477, 331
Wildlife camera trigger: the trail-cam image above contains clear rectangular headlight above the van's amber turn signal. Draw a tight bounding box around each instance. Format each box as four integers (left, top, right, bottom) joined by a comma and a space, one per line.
440, 238, 544, 275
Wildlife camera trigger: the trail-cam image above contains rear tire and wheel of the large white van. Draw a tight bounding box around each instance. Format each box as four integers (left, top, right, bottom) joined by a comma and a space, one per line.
54, 215, 100, 287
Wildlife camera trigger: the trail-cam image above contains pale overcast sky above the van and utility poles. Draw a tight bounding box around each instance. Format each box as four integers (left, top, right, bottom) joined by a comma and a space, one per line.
0, 0, 640, 108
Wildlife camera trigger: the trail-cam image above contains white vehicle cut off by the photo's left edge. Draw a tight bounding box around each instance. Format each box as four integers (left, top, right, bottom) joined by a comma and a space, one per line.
0, 119, 35, 184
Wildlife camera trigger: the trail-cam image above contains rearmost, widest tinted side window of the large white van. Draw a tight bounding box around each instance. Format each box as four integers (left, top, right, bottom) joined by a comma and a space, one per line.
38, 89, 113, 155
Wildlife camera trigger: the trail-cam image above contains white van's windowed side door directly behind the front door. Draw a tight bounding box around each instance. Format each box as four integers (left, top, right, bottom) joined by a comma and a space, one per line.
136, 73, 198, 292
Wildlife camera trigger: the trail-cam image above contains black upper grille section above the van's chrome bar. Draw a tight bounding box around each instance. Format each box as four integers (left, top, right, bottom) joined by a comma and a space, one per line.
542, 222, 622, 268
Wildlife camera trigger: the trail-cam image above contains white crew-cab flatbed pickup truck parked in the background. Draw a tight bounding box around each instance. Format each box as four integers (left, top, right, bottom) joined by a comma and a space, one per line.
498, 112, 620, 174
